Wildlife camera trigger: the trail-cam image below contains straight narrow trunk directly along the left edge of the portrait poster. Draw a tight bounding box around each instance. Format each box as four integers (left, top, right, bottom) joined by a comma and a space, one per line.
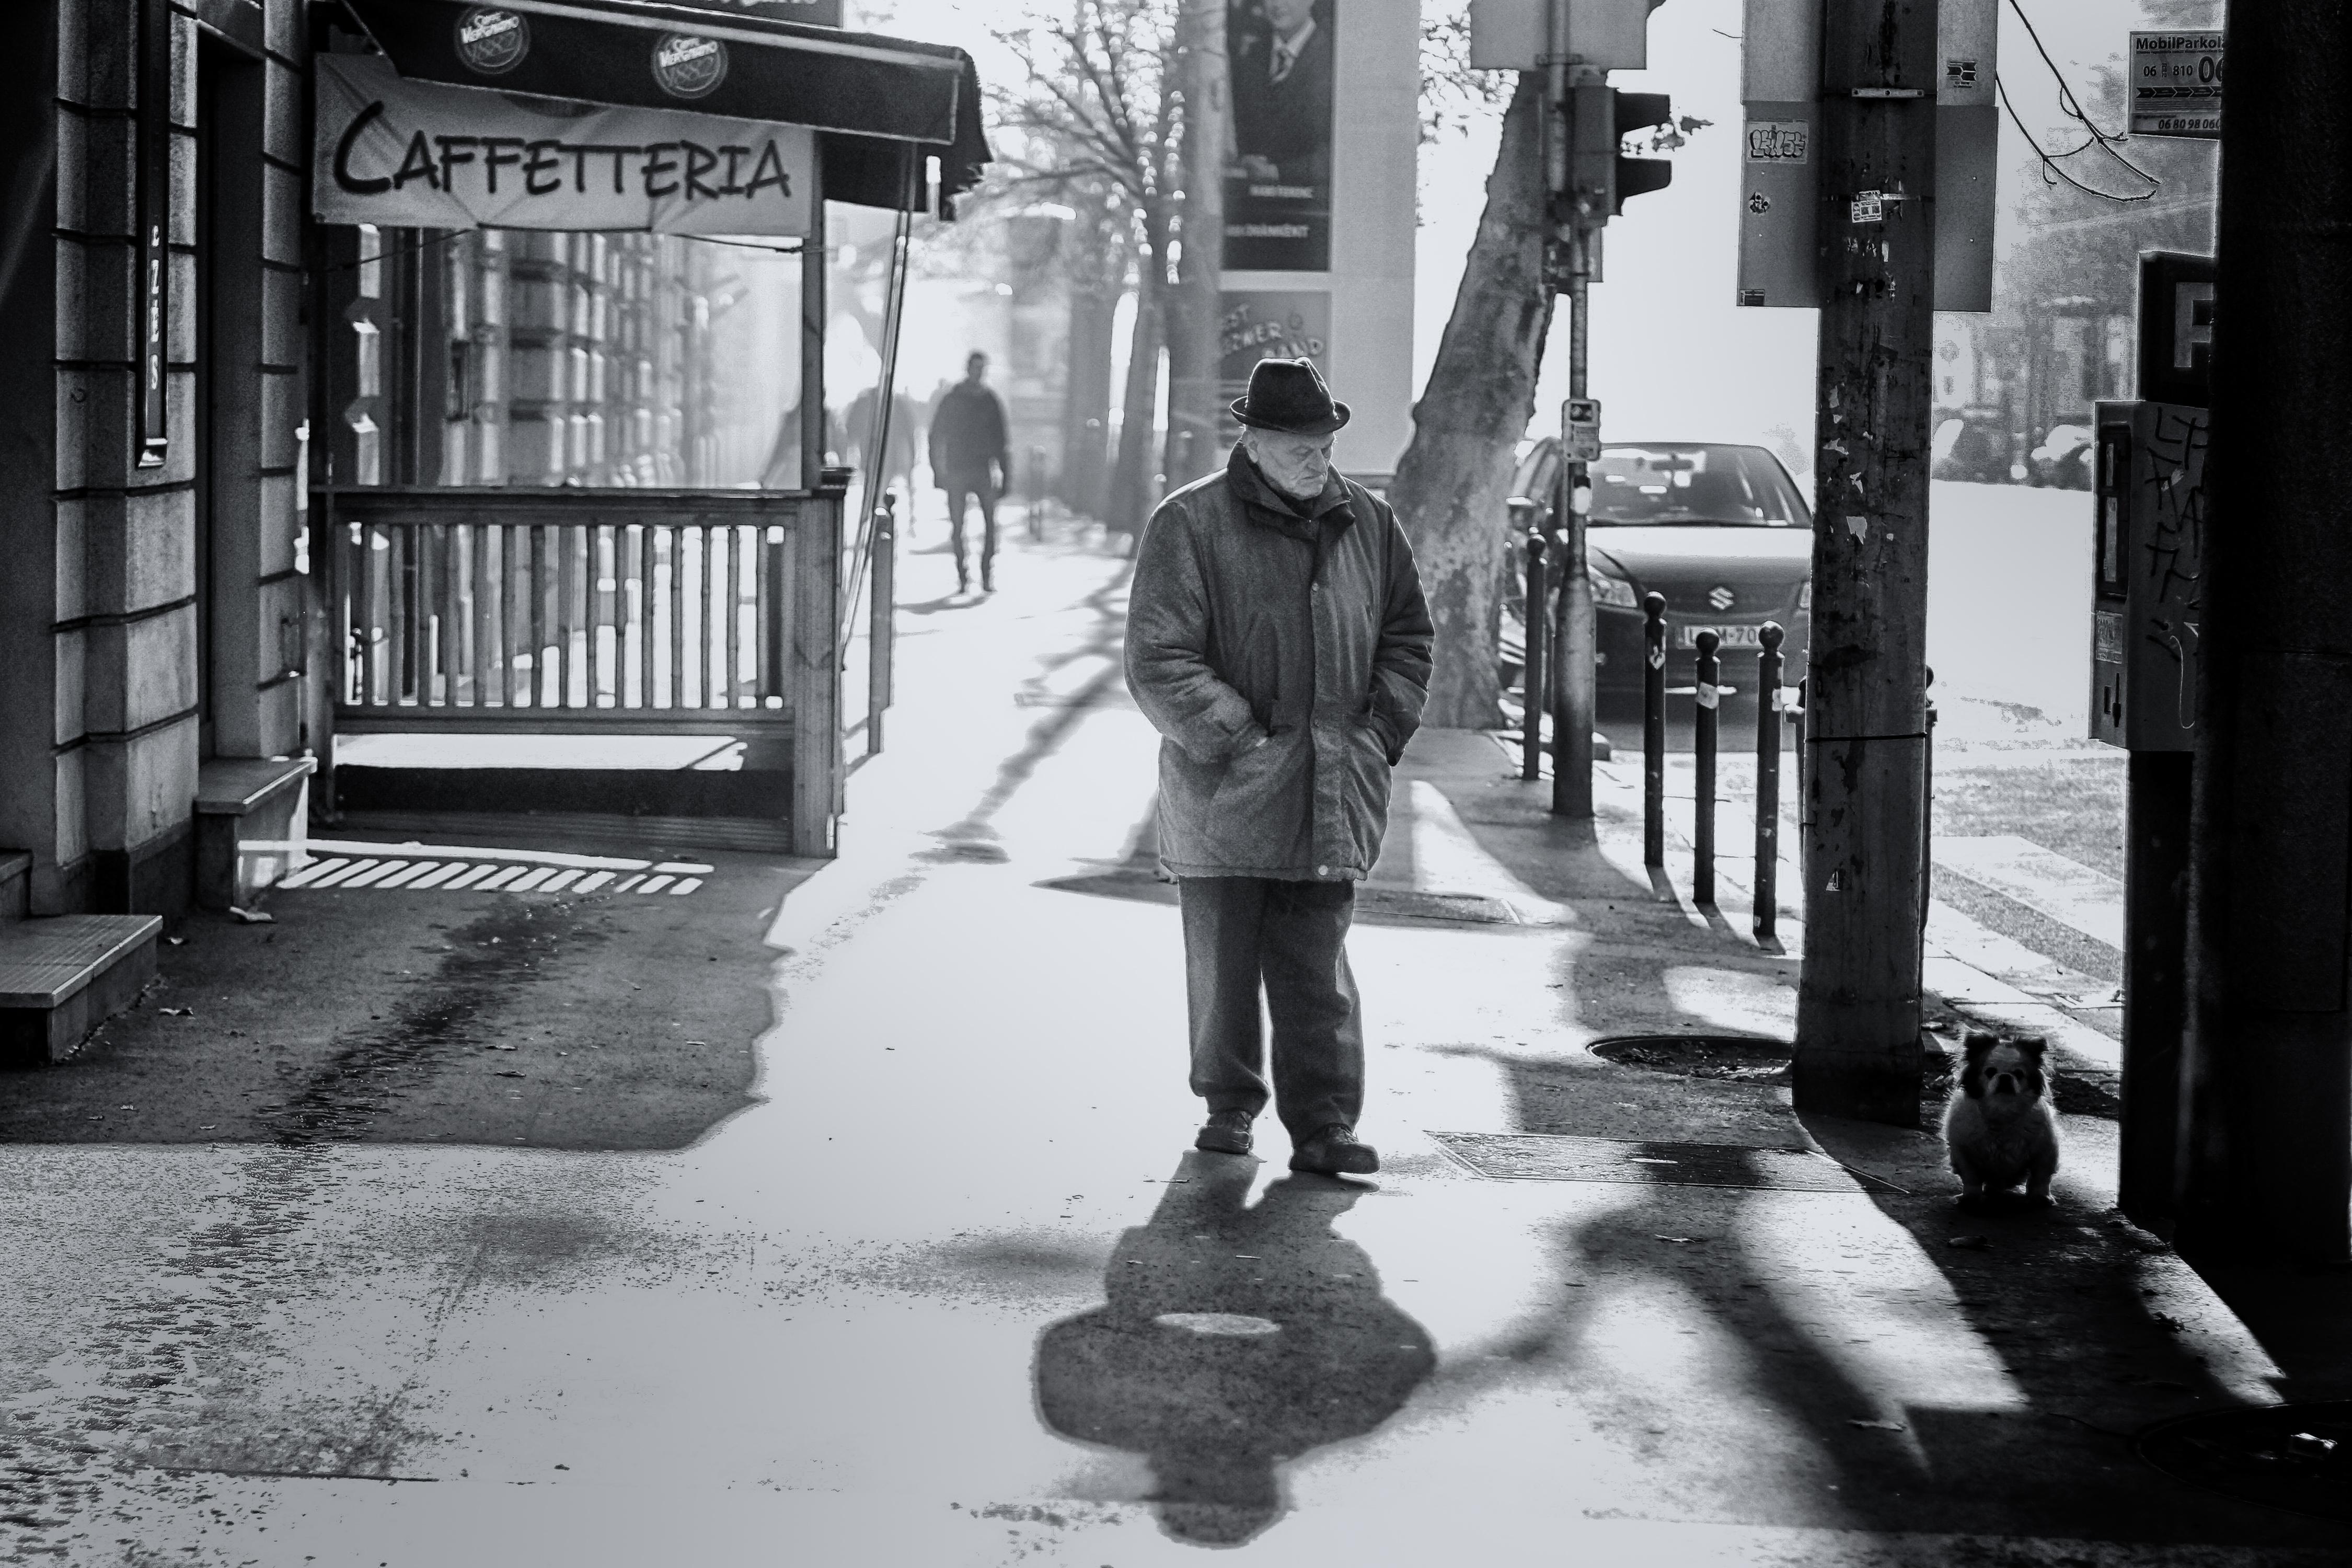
1160, 0, 1228, 489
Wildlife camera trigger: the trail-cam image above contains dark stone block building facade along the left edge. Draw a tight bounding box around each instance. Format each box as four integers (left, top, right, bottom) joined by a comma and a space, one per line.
0, 0, 310, 915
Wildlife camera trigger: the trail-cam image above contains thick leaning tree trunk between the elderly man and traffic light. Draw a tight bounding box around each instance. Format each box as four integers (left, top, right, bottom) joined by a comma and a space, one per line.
1390, 71, 1552, 729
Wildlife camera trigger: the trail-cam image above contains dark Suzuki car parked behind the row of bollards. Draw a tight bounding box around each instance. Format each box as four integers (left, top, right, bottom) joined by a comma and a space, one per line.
1505, 437, 1814, 694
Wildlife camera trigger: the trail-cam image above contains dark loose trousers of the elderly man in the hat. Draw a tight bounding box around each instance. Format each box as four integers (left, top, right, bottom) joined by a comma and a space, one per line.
1176, 877, 1364, 1140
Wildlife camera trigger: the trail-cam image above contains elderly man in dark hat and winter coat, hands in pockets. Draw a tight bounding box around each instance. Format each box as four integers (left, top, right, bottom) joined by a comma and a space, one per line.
1127, 360, 1433, 1175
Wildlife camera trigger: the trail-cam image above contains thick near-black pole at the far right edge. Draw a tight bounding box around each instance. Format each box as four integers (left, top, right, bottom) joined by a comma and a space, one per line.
2176, 0, 2352, 1265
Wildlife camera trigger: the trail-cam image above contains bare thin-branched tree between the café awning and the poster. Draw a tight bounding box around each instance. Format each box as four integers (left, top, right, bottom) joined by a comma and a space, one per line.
997, 0, 1183, 531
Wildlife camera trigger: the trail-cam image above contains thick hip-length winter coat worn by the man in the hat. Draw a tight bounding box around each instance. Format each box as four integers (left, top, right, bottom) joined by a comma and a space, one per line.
1127, 447, 1433, 882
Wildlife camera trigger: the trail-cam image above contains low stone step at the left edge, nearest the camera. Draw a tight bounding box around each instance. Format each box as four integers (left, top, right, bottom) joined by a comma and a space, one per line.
0, 915, 163, 1067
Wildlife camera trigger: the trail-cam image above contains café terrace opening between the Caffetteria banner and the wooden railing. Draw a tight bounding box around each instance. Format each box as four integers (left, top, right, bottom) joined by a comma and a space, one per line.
327, 226, 802, 489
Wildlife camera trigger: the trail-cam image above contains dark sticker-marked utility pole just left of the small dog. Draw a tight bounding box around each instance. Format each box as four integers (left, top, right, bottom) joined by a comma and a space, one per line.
1792, 0, 1929, 1126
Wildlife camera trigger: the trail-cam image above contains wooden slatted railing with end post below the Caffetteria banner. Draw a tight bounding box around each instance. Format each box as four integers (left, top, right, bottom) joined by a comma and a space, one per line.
315, 489, 842, 854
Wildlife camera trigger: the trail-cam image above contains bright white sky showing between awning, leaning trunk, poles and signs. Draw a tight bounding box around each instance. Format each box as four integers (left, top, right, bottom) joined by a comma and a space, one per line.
851, 0, 2201, 460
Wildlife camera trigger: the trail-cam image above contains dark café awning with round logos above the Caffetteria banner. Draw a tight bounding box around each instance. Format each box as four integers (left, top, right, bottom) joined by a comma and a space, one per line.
343, 0, 990, 216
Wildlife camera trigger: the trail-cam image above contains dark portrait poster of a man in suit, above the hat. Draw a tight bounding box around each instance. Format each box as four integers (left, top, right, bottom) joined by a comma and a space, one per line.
1226, 0, 1339, 273
